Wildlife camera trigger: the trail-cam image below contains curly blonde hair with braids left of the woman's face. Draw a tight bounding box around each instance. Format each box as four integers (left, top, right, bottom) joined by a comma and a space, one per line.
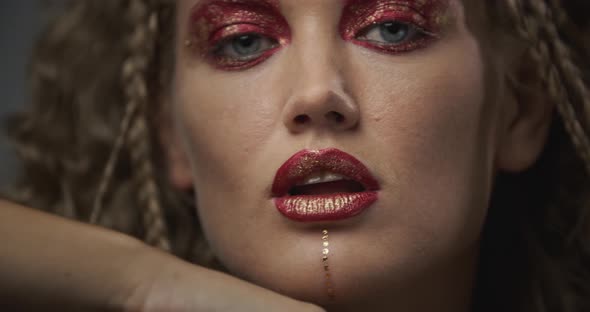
3, 0, 204, 264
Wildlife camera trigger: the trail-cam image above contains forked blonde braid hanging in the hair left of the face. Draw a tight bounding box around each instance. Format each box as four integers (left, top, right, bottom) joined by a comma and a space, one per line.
91, 0, 171, 250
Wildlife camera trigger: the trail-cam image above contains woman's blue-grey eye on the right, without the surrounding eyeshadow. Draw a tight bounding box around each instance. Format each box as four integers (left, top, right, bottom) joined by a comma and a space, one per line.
357, 21, 426, 45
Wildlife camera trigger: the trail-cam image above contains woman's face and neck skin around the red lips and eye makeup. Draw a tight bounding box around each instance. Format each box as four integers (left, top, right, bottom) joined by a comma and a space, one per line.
162, 0, 551, 311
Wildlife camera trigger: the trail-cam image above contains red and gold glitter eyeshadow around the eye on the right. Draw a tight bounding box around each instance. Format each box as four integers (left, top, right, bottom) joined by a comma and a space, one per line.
340, 0, 449, 53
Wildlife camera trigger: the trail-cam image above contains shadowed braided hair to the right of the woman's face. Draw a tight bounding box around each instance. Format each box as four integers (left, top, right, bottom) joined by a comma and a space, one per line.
474, 0, 590, 312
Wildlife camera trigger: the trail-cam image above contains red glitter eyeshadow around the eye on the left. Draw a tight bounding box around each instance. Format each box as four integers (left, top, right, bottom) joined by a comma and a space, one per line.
189, 0, 291, 70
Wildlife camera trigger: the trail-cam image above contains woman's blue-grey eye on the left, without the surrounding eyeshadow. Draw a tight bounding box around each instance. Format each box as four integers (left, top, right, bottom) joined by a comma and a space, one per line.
213, 33, 278, 61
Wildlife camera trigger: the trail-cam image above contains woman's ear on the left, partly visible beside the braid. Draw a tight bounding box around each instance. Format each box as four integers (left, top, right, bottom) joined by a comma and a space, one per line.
157, 101, 193, 191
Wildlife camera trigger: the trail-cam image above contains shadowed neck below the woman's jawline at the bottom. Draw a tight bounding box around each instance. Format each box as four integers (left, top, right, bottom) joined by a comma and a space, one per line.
326, 247, 479, 312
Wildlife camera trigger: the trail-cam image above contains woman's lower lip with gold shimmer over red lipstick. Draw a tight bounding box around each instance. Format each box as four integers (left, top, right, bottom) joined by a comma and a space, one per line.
274, 192, 377, 222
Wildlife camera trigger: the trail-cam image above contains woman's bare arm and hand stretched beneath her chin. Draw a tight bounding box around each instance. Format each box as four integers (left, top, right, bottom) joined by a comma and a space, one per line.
0, 201, 323, 312
